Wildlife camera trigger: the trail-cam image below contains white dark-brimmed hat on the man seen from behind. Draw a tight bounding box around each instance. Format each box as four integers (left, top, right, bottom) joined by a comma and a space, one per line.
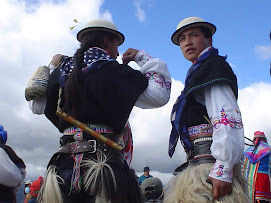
77, 19, 124, 45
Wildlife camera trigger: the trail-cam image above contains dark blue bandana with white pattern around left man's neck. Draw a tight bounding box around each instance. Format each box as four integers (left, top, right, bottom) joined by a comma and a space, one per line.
59, 47, 116, 87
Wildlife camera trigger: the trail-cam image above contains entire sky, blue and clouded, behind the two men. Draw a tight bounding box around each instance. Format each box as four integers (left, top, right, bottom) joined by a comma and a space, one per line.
0, 0, 271, 184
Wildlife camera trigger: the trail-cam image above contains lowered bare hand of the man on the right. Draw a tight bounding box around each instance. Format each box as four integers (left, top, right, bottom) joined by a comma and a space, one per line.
208, 176, 232, 199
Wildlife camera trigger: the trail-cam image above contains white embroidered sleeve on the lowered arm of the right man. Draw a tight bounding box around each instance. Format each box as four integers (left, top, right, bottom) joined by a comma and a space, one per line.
204, 82, 244, 182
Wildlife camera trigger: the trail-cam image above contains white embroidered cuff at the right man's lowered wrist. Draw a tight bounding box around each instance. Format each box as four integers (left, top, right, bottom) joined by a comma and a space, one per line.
209, 161, 233, 183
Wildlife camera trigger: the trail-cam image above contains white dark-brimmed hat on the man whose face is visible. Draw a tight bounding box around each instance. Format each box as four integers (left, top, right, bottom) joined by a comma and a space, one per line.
171, 17, 216, 45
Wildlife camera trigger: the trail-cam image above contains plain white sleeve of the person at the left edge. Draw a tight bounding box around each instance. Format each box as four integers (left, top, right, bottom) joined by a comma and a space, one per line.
0, 148, 23, 187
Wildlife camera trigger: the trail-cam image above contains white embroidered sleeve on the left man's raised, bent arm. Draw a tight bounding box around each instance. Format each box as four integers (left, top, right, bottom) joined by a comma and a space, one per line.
135, 51, 171, 109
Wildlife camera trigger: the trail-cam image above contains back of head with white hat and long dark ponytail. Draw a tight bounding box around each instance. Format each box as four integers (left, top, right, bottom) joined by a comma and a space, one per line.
63, 19, 124, 117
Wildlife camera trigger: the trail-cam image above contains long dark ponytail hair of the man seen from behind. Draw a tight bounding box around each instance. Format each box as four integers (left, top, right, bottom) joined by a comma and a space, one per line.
64, 30, 118, 116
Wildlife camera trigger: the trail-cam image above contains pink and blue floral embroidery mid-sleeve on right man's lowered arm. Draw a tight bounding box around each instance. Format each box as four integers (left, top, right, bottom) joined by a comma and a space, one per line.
210, 108, 243, 129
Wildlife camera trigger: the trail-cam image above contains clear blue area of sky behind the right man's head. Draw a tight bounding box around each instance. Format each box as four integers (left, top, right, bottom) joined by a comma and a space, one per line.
101, 0, 271, 88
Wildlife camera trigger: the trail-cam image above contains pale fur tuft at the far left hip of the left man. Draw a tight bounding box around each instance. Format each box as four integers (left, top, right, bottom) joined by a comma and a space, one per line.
38, 165, 64, 203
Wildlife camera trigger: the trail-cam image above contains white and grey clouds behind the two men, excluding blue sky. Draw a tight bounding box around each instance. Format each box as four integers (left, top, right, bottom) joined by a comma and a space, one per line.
0, 0, 271, 189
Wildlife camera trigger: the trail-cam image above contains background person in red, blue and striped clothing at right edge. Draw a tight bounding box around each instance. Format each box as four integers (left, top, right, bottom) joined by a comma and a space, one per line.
243, 131, 271, 203
